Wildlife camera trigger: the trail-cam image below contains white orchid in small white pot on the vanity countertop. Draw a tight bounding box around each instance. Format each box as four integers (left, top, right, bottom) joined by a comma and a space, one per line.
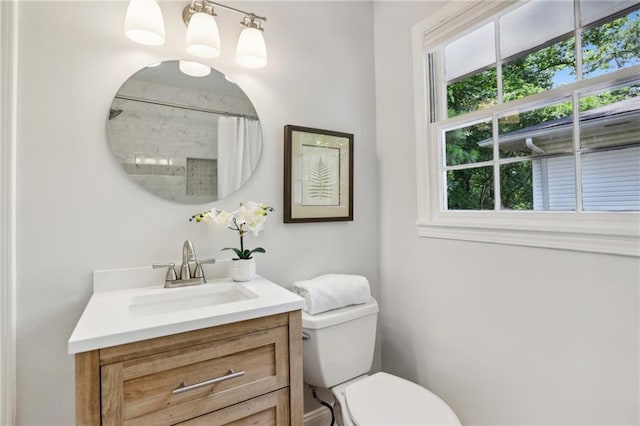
189, 201, 273, 281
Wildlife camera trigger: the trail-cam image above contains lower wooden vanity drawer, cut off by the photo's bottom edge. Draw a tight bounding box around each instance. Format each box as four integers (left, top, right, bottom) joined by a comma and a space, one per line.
179, 388, 289, 426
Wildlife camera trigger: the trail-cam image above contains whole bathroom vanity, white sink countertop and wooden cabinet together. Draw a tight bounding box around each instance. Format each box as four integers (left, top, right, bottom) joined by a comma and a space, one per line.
68, 268, 304, 426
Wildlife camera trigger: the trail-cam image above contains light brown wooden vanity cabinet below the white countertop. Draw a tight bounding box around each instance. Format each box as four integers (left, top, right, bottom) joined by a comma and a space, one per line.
76, 311, 303, 426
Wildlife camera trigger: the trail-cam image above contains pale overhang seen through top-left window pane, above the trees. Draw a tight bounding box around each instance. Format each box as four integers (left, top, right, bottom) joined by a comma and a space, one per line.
444, 22, 496, 81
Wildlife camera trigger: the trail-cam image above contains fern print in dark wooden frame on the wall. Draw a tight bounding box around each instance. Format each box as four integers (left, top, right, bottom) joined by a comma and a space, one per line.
284, 125, 353, 223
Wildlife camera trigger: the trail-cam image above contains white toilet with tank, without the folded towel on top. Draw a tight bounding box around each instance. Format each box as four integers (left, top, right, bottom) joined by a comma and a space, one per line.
302, 298, 460, 426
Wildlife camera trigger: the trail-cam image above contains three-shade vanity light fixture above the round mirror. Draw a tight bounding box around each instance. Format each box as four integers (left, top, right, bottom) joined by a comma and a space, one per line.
125, 0, 267, 68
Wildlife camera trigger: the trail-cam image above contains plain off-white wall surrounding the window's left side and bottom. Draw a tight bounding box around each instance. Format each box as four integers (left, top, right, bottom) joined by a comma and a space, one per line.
374, 2, 640, 425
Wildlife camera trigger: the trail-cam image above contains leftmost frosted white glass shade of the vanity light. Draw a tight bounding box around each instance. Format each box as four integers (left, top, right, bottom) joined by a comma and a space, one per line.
124, 0, 164, 46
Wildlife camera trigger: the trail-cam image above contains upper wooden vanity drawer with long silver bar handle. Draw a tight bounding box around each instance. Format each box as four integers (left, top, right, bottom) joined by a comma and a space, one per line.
101, 327, 289, 425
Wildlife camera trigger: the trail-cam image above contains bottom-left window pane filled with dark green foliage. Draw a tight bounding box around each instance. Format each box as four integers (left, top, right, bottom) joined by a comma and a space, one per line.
447, 167, 494, 210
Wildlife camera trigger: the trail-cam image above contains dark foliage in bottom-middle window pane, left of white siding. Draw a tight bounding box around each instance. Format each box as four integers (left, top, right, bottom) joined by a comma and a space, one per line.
500, 161, 533, 210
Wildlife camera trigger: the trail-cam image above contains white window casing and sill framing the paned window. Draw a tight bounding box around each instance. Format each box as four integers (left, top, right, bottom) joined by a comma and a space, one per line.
412, 0, 640, 257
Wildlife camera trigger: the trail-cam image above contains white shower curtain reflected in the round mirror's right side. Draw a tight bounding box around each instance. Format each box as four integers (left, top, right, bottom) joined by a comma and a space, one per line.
218, 117, 262, 198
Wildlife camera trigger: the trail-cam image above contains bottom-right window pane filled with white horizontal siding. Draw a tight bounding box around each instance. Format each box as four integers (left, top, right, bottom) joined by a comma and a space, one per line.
582, 146, 640, 211
